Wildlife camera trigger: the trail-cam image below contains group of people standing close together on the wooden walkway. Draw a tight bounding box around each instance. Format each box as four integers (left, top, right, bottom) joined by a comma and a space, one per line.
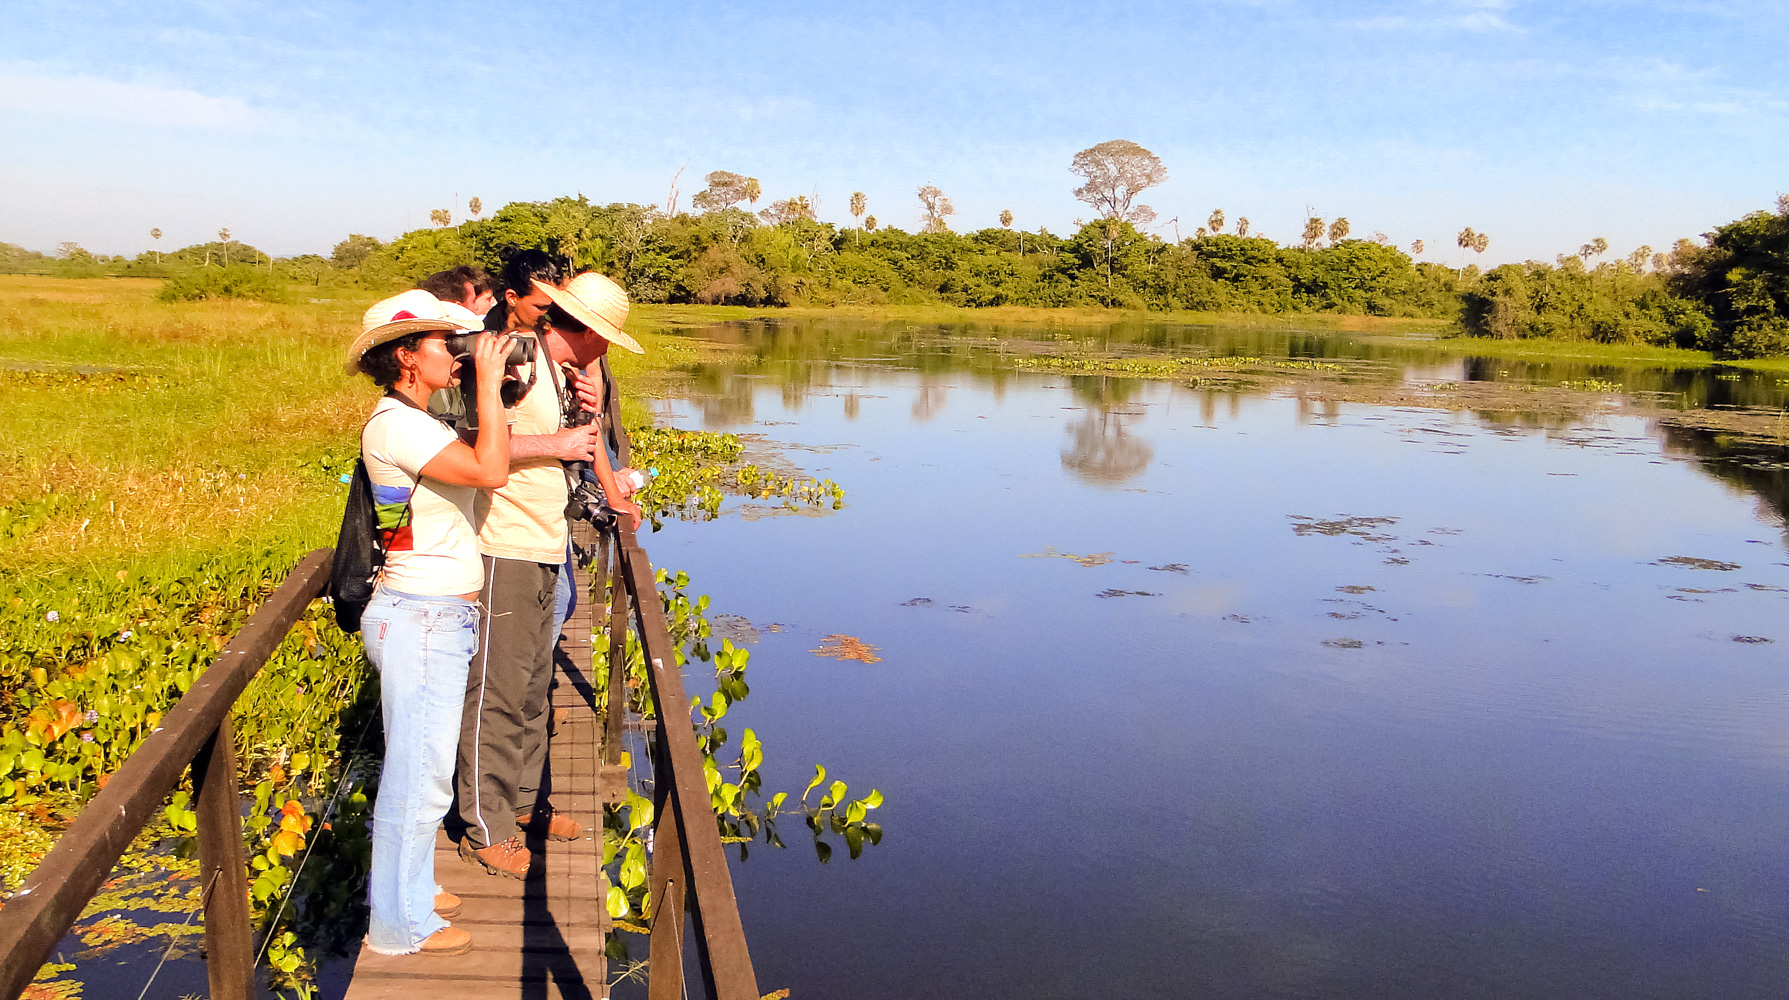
347, 250, 640, 955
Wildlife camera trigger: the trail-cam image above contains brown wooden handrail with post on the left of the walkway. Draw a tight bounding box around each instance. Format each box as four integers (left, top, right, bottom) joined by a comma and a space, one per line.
0, 549, 331, 1000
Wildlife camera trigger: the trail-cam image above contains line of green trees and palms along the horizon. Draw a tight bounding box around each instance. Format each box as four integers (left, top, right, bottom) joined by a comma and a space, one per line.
0, 140, 1789, 356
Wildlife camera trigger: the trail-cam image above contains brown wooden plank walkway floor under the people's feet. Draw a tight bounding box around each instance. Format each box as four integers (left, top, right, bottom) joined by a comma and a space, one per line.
345, 524, 624, 1000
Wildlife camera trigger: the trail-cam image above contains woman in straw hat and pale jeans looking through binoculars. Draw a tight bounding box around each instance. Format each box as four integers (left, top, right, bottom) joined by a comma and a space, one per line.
349, 288, 510, 955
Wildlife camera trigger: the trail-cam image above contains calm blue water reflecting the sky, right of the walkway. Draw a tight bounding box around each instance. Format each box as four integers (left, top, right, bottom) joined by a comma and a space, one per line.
629, 326, 1789, 1000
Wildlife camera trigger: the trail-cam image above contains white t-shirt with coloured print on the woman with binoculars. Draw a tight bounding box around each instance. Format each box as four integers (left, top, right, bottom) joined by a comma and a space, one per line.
360, 397, 485, 597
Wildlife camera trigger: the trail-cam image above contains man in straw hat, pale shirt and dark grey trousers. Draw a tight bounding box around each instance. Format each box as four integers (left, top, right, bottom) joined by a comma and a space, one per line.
456, 266, 640, 878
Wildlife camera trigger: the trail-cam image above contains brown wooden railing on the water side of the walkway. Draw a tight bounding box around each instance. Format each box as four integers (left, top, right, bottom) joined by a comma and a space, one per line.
605, 519, 759, 1000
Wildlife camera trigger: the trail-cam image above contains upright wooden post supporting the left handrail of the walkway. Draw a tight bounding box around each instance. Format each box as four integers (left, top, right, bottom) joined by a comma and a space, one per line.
193, 716, 254, 1000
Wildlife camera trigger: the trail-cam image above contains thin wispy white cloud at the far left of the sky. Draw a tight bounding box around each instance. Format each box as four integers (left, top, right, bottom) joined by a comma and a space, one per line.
0, 70, 256, 131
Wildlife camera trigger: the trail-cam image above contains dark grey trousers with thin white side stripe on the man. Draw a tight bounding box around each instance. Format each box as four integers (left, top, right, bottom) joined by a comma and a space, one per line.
454, 556, 560, 848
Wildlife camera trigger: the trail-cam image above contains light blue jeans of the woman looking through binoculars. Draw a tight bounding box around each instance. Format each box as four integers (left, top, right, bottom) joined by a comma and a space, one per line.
360, 587, 478, 955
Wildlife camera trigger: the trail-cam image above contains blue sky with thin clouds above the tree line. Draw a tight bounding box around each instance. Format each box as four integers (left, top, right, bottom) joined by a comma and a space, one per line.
0, 0, 1789, 263
